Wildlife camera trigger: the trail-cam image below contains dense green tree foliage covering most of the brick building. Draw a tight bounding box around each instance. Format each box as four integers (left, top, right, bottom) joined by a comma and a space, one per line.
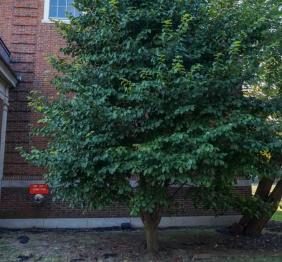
23, 0, 281, 250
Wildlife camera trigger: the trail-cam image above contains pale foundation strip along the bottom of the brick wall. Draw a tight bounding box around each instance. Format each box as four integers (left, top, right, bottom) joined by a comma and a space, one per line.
0, 215, 241, 228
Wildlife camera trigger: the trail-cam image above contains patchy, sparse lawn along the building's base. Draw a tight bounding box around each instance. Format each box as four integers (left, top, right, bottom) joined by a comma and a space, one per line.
0, 222, 282, 262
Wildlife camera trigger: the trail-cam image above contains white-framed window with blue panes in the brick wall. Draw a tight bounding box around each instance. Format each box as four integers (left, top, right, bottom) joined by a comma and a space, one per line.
43, 0, 79, 22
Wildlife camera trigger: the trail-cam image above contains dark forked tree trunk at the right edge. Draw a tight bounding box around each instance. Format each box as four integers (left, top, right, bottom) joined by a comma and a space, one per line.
230, 178, 282, 236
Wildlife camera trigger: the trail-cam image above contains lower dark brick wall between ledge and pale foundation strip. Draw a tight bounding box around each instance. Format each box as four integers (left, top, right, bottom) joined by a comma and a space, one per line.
0, 187, 250, 218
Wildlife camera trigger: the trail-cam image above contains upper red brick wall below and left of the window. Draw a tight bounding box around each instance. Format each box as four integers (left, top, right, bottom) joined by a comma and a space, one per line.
0, 0, 63, 179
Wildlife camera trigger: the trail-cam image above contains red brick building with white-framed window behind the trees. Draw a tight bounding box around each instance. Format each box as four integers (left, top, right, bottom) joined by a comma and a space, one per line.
0, 0, 250, 227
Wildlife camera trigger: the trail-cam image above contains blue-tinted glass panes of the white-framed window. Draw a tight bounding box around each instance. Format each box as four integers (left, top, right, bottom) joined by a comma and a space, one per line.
49, 0, 79, 19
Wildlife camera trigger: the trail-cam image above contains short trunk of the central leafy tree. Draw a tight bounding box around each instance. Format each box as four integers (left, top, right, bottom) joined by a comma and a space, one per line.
141, 208, 161, 253
